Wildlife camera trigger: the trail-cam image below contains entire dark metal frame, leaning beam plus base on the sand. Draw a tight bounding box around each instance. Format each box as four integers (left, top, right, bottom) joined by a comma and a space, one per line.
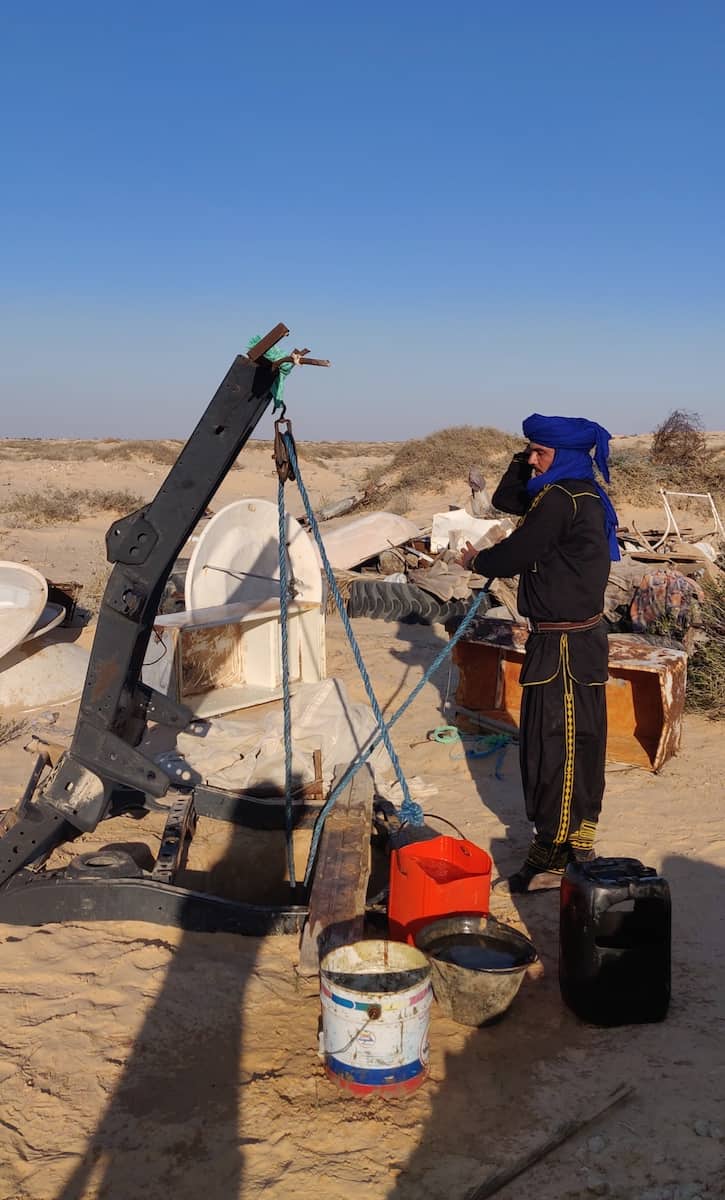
0, 324, 329, 936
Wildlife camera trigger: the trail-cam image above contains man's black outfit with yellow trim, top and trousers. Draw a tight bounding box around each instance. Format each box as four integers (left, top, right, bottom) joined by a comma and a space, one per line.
472, 457, 610, 869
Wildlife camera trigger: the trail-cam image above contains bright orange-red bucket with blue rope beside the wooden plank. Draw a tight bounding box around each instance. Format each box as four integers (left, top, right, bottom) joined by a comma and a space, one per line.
388, 836, 491, 946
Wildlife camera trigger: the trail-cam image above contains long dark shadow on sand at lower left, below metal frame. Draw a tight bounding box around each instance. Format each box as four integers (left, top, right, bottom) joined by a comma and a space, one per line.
56, 777, 301, 1200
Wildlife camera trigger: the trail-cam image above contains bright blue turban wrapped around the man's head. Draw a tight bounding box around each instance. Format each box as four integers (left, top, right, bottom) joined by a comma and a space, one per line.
523, 413, 621, 563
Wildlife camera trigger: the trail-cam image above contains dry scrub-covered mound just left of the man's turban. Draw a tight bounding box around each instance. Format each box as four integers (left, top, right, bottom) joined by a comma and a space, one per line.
367, 425, 522, 506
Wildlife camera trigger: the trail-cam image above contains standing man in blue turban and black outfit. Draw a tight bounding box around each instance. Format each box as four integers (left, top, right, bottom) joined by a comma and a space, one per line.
461, 413, 619, 892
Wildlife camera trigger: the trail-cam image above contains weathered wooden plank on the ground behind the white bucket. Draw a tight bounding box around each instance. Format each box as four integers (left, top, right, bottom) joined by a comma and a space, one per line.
299, 767, 373, 974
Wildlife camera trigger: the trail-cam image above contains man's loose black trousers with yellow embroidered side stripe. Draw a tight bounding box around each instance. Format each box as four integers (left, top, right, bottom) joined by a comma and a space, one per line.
520, 626, 609, 868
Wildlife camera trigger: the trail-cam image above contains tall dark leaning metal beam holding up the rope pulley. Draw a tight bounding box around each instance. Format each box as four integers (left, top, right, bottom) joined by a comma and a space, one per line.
36, 348, 281, 830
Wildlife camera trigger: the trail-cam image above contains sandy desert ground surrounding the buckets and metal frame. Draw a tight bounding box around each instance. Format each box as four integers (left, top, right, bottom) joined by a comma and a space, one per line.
0, 441, 725, 1200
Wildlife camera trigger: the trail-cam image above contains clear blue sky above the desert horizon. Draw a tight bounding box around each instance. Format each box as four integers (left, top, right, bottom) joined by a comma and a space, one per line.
0, 0, 725, 439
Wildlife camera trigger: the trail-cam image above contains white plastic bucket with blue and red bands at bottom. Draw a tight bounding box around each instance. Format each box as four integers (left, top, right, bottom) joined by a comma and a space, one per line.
319, 941, 433, 1096
